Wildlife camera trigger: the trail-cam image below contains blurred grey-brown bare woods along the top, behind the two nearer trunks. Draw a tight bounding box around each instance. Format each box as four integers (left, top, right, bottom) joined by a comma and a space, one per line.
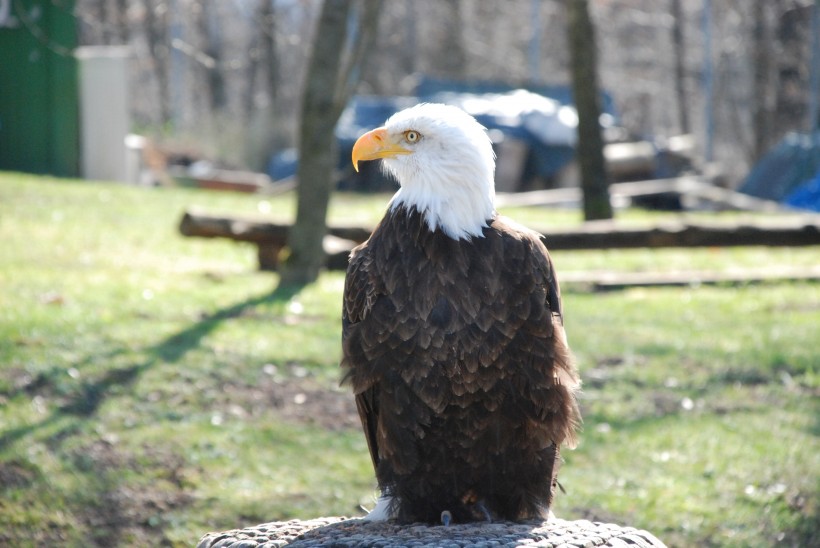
74, 0, 812, 182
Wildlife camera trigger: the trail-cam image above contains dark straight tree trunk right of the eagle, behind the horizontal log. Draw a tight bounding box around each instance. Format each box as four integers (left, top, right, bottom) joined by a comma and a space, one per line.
567, 0, 612, 221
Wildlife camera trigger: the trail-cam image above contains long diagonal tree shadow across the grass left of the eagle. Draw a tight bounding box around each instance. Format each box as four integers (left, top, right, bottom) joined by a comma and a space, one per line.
0, 285, 304, 449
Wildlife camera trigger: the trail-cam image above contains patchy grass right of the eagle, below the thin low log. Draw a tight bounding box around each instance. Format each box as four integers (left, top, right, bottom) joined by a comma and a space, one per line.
556, 284, 820, 546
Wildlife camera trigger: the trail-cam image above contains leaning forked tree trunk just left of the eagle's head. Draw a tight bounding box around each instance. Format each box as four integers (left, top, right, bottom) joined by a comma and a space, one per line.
281, 0, 381, 285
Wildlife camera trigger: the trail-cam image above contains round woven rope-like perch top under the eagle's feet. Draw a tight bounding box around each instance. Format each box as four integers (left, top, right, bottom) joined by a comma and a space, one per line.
197, 517, 665, 548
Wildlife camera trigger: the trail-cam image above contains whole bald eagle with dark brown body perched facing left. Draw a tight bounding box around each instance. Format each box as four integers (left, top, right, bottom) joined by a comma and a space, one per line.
341, 104, 581, 523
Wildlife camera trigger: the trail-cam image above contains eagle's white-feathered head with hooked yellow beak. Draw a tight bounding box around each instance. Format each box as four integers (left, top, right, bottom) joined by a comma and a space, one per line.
353, 103, 495, 240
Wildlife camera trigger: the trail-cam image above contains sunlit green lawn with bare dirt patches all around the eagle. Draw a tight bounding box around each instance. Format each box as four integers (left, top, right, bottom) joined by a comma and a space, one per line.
0, 173, 820, 546
